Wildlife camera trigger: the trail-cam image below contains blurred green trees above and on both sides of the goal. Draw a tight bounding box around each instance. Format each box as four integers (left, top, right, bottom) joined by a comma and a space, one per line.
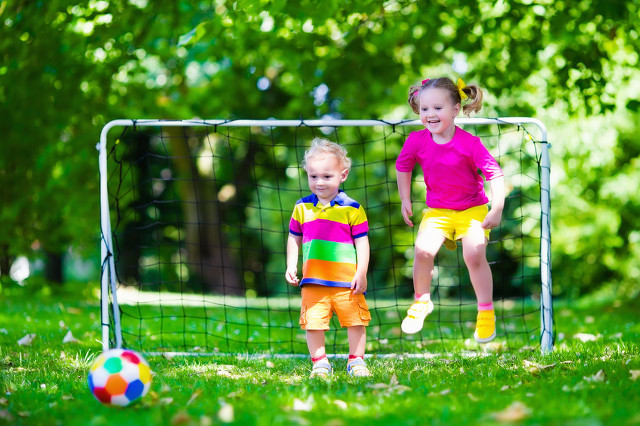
0, 0, 640, 424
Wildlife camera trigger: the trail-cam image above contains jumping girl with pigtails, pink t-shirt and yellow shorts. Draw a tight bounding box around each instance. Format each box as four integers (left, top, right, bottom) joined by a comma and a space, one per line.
396, 77, 504, 343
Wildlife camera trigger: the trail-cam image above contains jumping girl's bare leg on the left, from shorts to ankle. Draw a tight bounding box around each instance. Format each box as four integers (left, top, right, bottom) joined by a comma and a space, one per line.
413, 228, 445, 295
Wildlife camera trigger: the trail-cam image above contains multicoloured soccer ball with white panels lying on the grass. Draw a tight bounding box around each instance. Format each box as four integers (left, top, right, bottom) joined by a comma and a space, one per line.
88, 349, 151, 407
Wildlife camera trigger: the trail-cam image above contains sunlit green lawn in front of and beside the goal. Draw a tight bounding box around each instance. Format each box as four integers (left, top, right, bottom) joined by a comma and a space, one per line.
0, 285, 640, 426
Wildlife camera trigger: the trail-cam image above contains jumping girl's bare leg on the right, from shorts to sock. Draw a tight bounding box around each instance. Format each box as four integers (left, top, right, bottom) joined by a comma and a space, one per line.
462, 226, 493, 305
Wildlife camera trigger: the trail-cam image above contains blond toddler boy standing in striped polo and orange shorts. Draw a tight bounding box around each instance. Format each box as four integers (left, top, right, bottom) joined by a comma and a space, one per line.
285, 138, 371, 378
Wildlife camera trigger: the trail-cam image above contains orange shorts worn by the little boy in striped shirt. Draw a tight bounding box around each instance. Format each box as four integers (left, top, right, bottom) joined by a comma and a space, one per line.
300, 284, 371, 330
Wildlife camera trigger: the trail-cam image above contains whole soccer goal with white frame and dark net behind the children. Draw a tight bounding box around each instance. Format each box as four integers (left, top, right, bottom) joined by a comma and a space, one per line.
97, 118, 554, 356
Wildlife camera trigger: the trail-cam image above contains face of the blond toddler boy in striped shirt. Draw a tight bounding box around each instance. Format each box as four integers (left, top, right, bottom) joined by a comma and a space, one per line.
307, 154, 349, 204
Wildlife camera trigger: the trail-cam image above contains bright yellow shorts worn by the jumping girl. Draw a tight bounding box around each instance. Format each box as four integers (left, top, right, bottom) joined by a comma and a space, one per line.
418, 205, 491, 250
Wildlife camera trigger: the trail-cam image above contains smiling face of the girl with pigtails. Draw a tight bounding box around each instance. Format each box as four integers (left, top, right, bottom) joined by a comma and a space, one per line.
420, 87, 460, 142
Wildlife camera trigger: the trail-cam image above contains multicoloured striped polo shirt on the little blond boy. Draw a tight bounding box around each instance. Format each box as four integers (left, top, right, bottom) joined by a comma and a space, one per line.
289, 190, 369, 287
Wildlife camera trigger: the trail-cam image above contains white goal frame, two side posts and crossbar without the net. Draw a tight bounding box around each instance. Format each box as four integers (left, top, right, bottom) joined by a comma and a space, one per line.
96, 117, 554, 354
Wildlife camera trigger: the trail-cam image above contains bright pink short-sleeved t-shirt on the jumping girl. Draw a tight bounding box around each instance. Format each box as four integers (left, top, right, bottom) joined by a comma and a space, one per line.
396, 126, 502, 210
